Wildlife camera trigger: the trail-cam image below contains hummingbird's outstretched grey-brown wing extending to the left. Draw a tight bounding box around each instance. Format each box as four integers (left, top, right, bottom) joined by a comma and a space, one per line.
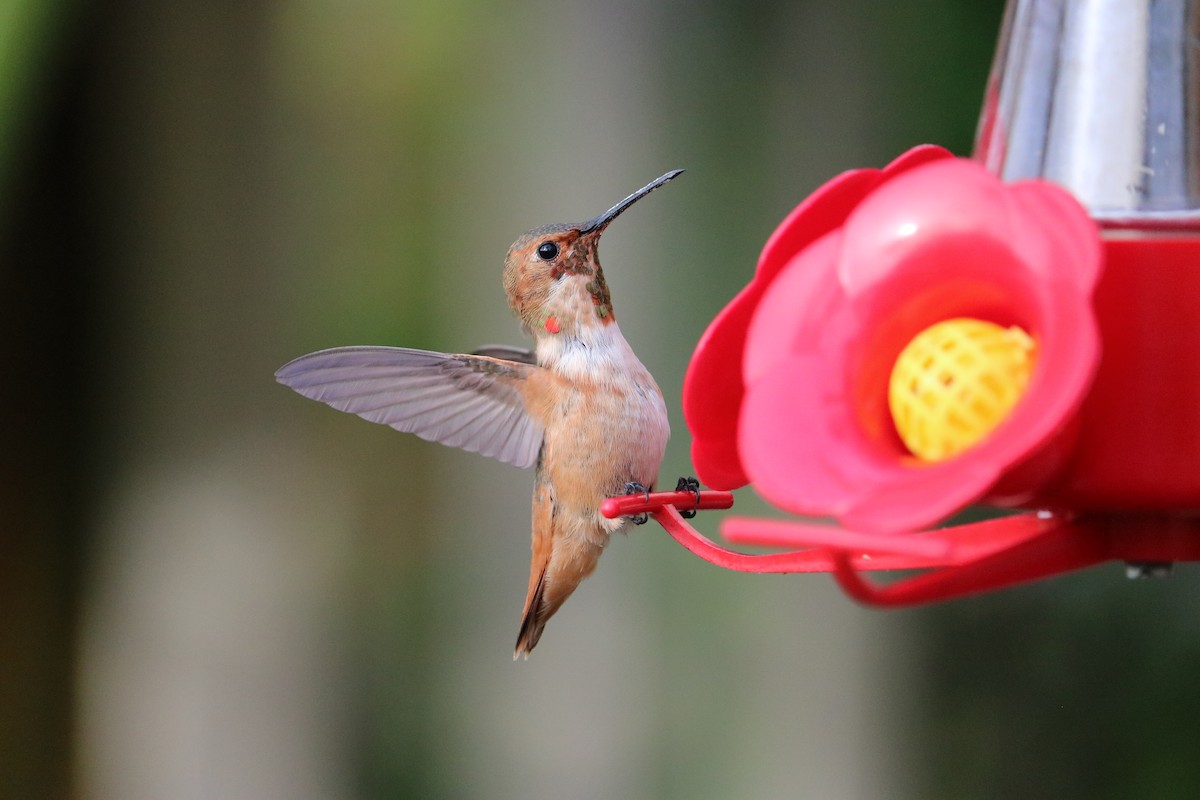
275, 347, 542, 467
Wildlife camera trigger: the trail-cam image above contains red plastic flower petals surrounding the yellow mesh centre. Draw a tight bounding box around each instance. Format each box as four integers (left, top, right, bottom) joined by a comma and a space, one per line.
684, 146, 1102, 531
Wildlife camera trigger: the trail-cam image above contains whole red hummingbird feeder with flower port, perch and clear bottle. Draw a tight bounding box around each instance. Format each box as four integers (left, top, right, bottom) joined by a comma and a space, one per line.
628, 0, 1200, 607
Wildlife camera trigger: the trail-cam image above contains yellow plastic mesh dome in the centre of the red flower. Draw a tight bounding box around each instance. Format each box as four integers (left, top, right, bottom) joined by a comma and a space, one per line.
888, 317, 1037, 461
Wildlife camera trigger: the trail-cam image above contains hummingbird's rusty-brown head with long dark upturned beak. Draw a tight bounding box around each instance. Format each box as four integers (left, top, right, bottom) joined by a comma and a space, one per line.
504, 169, 683, 337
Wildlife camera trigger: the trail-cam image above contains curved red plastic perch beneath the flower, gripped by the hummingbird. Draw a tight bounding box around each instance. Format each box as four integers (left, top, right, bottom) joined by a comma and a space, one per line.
601, 491, 1200, 608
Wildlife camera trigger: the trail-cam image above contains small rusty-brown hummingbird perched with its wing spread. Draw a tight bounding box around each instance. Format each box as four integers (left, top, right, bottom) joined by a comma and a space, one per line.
275, 169, 683, 658
